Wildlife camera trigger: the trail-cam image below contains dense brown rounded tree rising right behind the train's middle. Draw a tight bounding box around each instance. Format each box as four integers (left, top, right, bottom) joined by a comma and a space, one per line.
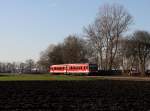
63, 35, 87, 63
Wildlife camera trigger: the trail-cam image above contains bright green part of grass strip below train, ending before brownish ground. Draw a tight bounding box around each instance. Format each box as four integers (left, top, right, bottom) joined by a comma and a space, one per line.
0, 74, 102, 81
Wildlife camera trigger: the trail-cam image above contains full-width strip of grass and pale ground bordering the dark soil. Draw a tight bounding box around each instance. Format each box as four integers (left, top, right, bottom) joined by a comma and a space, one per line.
0, 74, 150, 81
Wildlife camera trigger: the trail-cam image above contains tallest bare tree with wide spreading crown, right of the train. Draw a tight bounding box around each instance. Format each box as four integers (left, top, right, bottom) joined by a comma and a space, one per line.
97, 4, 132, 69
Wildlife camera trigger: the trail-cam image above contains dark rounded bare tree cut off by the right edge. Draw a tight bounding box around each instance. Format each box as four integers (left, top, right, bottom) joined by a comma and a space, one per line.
130, 31, 150, 75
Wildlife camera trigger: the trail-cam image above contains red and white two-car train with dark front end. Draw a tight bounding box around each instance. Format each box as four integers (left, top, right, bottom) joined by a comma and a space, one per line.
49, 63, 98, 74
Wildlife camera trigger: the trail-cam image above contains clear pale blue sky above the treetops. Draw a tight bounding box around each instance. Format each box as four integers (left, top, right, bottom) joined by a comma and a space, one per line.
0, 0, 150, 62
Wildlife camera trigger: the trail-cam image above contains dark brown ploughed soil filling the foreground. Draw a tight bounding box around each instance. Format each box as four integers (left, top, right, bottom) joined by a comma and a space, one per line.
0, 80, 150, 111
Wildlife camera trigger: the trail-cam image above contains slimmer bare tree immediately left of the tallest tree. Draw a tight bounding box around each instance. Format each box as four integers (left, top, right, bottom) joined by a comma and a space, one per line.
84, 21, 103, 69
